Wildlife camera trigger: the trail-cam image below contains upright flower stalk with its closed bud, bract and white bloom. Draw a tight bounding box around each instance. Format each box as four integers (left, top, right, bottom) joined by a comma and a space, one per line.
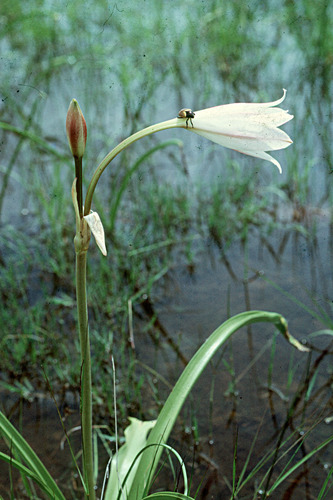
66, 91, 293, 500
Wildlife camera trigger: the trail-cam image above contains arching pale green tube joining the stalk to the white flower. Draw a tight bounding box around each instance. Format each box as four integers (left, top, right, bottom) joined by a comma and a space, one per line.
84, 118, 180, 215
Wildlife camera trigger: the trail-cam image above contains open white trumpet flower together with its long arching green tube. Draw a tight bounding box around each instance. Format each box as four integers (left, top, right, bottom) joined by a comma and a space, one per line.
84, 90, 293, 215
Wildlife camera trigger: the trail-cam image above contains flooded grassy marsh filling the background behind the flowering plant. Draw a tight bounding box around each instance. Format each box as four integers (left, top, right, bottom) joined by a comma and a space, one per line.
0, 0, 333, 500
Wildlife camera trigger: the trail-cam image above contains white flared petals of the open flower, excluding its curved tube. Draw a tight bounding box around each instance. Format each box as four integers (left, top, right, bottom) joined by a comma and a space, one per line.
187, 90, 293, 173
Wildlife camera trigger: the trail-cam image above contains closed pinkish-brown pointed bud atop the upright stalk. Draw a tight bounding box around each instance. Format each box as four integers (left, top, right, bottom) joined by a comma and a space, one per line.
66, 99, 87, 158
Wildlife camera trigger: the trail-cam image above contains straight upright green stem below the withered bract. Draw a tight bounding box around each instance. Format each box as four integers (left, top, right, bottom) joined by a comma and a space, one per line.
76, 250, 95, 500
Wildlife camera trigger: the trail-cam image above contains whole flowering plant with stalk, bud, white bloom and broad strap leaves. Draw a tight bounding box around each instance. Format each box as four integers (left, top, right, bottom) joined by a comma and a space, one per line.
0, 91, 312, 500
